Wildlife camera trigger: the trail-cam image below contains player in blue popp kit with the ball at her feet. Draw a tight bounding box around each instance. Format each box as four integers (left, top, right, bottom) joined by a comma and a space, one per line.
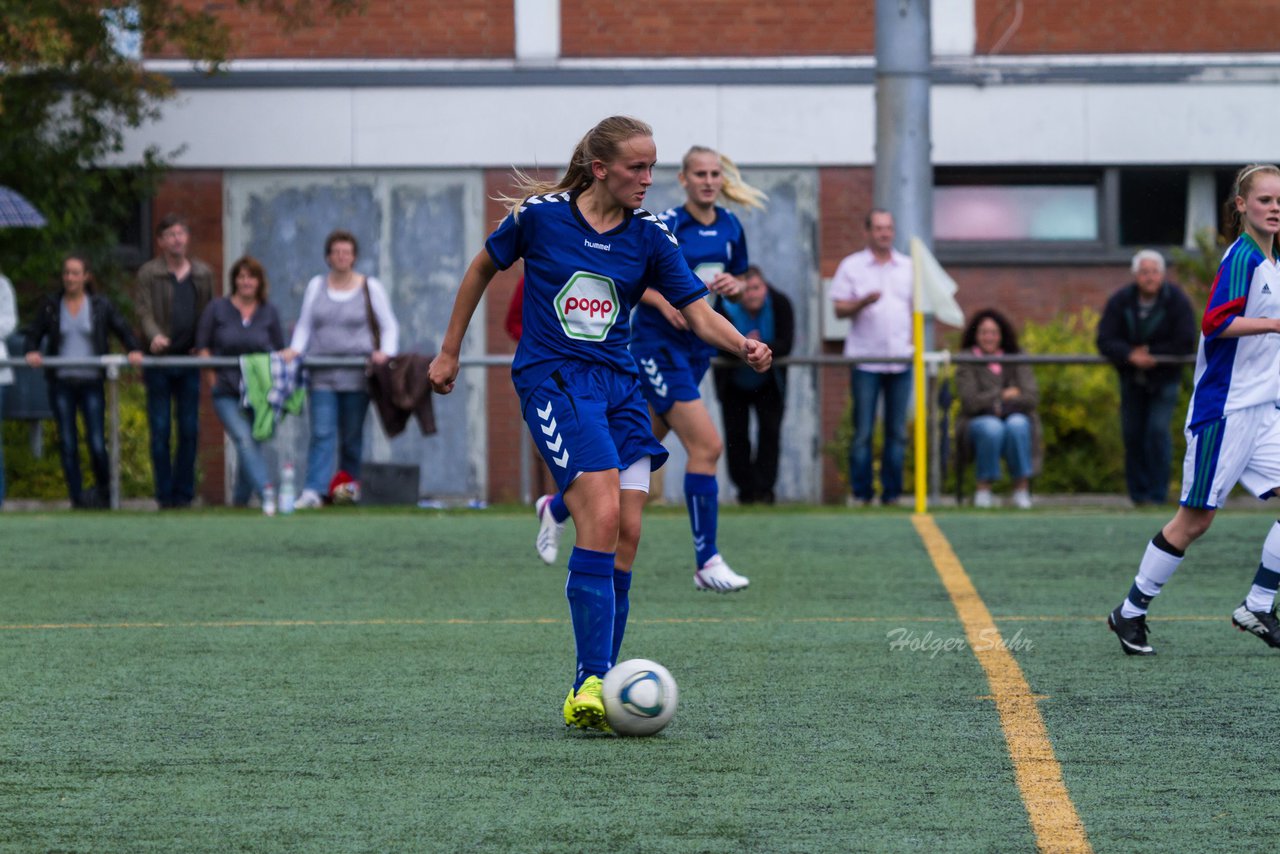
430, 117, 773, 729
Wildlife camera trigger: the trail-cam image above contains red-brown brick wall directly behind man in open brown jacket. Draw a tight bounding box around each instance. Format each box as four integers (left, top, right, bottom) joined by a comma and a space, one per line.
151, 170, 227, 504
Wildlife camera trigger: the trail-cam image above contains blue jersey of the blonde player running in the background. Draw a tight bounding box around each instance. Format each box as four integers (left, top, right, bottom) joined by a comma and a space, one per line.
631, 206, 748, 356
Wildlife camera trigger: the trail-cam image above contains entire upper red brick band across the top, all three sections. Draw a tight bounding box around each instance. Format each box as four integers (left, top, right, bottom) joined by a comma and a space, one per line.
152, 0, 1275, 59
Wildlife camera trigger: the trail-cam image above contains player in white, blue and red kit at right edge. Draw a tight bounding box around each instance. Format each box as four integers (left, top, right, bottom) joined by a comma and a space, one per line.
1107, 164, 1280, 656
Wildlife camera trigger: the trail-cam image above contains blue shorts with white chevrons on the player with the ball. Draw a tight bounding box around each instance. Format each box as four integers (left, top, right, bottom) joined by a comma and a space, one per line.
524, 361, 668, 492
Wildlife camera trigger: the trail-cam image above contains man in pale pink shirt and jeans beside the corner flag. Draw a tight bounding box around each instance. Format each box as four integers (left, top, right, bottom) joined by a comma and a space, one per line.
831, 209, 914, 506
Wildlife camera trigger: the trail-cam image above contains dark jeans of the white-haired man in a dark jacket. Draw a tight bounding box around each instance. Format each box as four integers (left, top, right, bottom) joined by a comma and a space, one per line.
1120, 376, 1180, 504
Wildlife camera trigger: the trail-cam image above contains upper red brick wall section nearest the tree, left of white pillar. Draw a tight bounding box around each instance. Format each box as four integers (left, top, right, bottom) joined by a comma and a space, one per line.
160, 0, 516, 59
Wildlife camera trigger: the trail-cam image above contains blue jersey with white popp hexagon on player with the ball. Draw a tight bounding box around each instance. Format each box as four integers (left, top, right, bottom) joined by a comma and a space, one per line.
485, 192, 707, 398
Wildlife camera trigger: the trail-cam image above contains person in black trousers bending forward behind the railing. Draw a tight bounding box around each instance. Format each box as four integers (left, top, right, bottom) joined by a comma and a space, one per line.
714, 265, 795, 504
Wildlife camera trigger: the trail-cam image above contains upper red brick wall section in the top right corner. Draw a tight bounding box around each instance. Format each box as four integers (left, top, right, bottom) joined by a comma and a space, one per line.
974, 0, 1276, 55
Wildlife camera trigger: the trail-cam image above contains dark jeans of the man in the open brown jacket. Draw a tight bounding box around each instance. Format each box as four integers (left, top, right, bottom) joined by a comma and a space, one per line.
142, 367, 200, 507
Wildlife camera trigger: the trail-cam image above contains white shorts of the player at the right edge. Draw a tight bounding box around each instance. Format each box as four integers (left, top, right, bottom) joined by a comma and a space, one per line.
1181, 403, 1280, 510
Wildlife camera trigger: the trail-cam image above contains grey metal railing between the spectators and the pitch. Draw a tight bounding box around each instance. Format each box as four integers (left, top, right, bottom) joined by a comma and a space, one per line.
0, 350, 1196, 510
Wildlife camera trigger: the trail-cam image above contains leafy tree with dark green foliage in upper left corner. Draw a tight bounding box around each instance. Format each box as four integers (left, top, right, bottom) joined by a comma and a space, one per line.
0, 0, 362, 303
